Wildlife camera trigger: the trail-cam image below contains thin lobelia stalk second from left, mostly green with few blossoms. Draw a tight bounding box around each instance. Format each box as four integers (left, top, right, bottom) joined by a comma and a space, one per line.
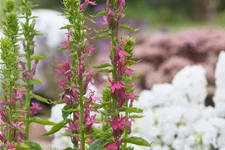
20, 0, 43, 140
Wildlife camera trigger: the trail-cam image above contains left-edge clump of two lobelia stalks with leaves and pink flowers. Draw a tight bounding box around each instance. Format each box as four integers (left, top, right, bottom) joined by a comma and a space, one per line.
0, 0, 54, 150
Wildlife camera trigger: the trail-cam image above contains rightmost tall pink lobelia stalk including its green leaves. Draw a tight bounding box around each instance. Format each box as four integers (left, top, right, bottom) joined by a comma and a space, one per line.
89, 0, 150, 150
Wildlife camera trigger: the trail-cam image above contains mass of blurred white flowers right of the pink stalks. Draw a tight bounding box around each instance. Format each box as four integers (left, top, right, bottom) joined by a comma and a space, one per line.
132, 52, 225, 150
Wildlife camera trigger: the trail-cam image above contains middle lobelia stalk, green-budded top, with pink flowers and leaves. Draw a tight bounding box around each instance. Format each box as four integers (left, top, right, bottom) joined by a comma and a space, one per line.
45, 0, 96, 150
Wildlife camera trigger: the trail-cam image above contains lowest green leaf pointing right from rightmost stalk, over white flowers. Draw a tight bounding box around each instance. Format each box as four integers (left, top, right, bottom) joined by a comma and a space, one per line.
123, 136, 151, 147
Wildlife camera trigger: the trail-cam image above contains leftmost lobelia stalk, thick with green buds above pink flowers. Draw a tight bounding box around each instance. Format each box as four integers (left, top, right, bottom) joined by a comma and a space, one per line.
0, 0, 24, 148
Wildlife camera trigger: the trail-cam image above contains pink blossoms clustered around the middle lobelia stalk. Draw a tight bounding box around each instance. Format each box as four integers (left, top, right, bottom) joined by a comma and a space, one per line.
55, 0, 97, 146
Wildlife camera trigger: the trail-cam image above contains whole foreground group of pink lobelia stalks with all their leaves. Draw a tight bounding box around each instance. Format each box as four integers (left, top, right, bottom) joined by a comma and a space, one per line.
0, 0, 150, 150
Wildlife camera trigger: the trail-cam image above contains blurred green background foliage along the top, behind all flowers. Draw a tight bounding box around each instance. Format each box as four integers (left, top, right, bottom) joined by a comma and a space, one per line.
0, 0, 225, 30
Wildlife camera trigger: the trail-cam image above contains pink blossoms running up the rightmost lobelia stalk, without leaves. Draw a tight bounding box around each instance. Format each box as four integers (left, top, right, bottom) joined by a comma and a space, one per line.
104, 0, 136, 150
